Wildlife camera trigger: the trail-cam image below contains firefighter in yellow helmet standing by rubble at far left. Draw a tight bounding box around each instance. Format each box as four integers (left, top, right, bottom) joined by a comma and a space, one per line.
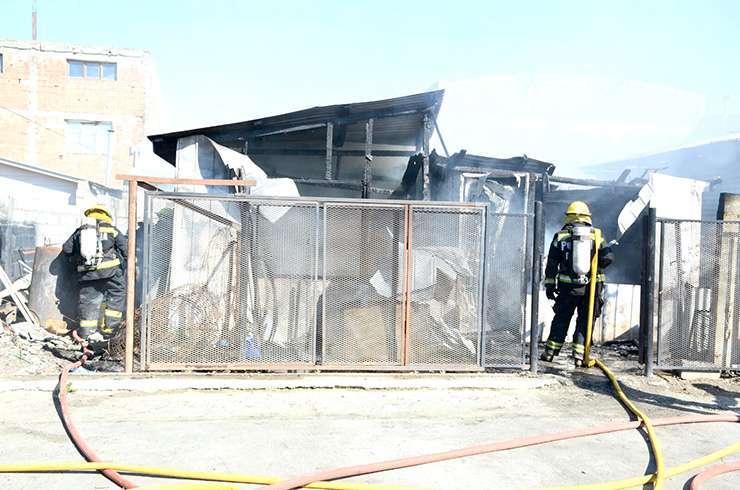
63, 205, 128, 353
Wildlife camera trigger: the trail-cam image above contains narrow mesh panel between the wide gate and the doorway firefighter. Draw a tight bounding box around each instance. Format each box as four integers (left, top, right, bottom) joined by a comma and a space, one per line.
483, 214, 531, 367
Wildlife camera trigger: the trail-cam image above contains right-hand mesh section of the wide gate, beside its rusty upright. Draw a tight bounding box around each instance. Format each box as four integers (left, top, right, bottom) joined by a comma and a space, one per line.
407, 206, 484, 365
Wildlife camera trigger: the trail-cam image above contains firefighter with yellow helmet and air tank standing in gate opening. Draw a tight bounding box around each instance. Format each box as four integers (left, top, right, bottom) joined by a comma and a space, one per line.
541, 201, 614, 367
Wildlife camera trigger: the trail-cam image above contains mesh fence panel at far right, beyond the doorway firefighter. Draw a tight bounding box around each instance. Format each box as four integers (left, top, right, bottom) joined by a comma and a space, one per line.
657, 220, 740, 369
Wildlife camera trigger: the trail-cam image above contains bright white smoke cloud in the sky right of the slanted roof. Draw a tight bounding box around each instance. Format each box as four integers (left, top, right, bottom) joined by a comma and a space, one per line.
436, 75, 706, 175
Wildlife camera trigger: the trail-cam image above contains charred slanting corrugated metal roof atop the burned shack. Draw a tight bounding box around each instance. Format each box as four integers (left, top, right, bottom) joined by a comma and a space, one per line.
149, 90, 444, 164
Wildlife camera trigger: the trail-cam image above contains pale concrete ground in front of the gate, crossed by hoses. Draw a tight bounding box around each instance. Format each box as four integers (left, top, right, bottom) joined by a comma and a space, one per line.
0, 363, 740, 490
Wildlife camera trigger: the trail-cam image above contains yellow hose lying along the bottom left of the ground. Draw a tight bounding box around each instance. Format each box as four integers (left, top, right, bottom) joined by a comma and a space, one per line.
0, 462, 428, 490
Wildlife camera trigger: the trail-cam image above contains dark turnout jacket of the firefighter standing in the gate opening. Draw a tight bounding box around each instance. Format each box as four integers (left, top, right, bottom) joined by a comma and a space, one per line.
545, 222, 614, 296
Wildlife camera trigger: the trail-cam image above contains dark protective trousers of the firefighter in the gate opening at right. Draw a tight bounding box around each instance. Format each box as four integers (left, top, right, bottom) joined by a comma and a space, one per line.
545, 293, 597, 360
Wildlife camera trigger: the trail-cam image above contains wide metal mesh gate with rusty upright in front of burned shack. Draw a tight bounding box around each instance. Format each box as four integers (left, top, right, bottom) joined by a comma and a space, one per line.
141, 193, 486, 370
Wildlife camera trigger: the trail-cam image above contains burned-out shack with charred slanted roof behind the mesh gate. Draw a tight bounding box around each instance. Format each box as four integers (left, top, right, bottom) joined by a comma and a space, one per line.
137, 91, 716, 367
